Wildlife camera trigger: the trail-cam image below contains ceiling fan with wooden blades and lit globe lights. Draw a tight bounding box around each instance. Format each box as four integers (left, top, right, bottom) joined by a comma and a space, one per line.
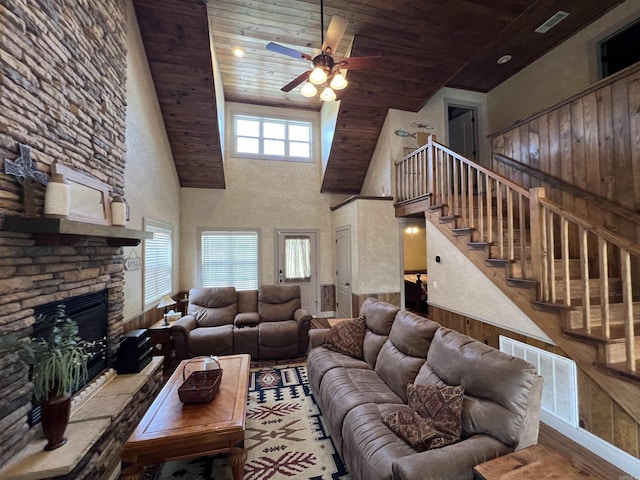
266, 0, 382, 101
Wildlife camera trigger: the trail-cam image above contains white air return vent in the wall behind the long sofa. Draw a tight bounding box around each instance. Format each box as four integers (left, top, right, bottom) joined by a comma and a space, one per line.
500, 335, 578, 428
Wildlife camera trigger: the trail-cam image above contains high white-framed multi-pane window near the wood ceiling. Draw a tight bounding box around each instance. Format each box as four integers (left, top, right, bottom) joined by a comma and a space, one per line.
233, 115, 312, 162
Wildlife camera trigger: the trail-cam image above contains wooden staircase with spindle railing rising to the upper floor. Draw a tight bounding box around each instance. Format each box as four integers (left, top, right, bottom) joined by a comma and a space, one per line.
396, 138, 640, 422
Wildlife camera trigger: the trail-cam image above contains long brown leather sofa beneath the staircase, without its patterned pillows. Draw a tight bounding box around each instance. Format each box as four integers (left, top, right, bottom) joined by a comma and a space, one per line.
307, 298, 542, 480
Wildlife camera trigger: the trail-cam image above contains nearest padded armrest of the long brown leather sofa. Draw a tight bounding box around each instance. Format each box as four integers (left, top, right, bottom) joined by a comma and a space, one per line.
391, 434, 513, 480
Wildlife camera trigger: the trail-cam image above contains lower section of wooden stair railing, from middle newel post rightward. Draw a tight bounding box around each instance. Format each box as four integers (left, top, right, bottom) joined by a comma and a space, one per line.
532, 193, 640, 378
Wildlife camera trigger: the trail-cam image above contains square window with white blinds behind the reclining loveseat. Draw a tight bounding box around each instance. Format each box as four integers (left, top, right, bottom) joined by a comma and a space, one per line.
200, 230, 258, 290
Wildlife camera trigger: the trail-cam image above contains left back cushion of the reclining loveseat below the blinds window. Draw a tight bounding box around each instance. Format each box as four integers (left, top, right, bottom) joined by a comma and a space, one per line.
187, 287, 238, 327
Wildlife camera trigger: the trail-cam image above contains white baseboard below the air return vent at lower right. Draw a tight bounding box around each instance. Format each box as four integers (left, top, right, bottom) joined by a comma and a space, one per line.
540, 411, 640, 480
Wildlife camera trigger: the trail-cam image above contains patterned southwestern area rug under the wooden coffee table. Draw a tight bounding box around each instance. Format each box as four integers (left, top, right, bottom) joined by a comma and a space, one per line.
145, 364, 349, 480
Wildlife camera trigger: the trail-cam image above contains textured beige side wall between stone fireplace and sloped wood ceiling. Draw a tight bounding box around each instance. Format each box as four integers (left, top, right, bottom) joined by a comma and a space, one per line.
124, 1, 180, 320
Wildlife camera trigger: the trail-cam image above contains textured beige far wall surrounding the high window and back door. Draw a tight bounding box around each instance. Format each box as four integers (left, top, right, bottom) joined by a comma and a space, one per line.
180, 103, 344, 289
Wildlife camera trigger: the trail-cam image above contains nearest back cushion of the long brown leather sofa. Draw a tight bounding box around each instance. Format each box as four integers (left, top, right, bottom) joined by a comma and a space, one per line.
427, 328, 538, 447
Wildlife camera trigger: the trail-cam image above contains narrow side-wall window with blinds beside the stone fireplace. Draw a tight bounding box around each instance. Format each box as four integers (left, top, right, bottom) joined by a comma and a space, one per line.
143, 219, 173, 306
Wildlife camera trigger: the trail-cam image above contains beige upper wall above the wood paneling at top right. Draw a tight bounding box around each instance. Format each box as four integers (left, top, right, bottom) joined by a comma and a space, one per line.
487, 0, 640, 133
